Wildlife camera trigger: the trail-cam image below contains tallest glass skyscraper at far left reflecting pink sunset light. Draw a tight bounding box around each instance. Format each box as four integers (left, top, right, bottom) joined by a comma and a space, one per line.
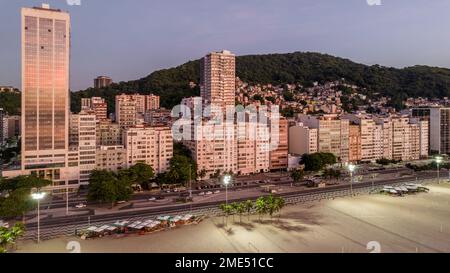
21, 4, 70, 185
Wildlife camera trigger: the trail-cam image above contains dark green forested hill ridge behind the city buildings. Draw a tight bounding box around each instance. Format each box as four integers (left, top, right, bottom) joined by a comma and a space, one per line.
67, 52, 450, 112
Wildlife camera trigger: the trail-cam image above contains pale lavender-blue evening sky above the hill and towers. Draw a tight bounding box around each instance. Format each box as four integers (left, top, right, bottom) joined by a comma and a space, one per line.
0, 0, 450, 91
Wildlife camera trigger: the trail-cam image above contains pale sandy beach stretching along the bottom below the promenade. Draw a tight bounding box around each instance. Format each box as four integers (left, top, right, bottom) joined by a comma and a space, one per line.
17, 184, 450, 253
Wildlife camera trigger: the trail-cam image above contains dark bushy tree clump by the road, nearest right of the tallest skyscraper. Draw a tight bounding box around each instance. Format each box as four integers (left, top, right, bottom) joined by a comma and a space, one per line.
88, 170, 133, 207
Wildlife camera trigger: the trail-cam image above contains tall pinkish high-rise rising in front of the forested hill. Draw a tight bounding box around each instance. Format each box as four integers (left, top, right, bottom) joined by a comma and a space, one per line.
200, 50, 236, 111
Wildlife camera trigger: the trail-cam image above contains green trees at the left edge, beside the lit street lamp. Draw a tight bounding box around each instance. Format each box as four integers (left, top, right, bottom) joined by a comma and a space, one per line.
0, 176, 52, 219
